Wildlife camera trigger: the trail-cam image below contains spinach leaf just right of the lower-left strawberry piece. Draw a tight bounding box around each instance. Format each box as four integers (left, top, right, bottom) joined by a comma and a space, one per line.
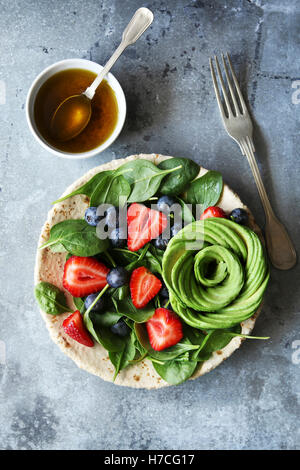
83, 310, 124, 352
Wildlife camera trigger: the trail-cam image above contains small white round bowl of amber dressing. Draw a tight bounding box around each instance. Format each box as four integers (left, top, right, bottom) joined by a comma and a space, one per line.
26, 59, 126, 159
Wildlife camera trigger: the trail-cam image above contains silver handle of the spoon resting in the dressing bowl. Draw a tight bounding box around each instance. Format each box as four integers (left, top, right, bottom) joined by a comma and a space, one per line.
83, 8, 153, 100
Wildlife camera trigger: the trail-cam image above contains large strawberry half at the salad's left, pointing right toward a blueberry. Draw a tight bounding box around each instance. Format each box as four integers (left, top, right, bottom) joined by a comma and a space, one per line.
63, 256, 109, 297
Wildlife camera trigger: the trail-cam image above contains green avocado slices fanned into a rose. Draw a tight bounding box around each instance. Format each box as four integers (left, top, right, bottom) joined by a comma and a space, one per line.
162, 218, 269, 330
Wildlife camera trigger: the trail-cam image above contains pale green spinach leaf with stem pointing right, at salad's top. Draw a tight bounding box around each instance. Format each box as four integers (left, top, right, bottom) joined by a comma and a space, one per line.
116, 159, 181, 202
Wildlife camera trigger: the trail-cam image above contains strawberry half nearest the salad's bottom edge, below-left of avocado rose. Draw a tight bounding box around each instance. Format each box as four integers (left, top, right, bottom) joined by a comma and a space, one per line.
146, 308, 183, 351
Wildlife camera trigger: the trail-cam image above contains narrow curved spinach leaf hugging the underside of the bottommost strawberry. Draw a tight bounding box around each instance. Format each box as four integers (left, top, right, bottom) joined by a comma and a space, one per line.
134, 323, 198, 362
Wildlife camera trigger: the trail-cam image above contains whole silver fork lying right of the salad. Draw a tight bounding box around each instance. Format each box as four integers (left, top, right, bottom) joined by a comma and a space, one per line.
209, 53, 297, 269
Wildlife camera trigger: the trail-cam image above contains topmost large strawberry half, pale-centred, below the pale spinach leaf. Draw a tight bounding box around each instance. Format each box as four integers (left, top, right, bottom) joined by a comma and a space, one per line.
127, 202, 168, 251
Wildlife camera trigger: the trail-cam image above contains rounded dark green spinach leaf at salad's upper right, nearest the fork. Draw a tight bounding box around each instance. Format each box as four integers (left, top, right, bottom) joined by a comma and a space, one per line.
186, 171, 223, 211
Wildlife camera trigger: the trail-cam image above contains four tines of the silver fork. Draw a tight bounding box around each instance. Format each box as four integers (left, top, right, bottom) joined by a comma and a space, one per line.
209, 52, 247, 119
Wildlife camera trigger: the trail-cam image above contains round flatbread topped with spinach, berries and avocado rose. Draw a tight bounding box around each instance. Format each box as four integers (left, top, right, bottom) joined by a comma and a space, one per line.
35, 154, 269, 388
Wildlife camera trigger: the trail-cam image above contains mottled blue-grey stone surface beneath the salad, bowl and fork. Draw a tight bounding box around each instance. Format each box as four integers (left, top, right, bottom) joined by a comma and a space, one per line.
0, 0, 300, 449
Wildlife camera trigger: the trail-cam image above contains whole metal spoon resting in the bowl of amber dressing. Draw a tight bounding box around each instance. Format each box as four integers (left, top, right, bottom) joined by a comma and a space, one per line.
51, 8, 153, 142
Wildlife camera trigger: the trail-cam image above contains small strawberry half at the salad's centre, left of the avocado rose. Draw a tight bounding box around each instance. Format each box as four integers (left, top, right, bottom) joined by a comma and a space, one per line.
130, 266, 162, 308
